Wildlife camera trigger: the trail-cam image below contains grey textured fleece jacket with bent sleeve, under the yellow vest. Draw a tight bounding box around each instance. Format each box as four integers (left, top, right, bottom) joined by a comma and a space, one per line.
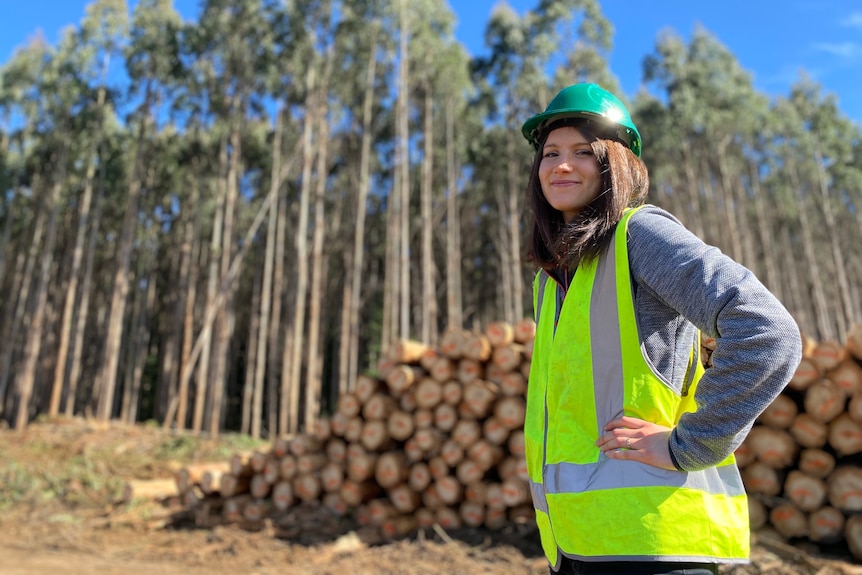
628, 205, 802, 471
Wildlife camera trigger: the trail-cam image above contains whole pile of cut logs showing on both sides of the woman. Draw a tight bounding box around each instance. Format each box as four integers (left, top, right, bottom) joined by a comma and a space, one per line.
170, 320, 862, 559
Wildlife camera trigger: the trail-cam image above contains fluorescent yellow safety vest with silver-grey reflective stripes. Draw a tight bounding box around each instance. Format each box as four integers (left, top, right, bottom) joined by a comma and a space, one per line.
524, 206, 749, 568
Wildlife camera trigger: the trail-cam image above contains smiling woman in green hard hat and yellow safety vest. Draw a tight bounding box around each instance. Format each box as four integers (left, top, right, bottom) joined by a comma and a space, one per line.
522, 84, 802, 574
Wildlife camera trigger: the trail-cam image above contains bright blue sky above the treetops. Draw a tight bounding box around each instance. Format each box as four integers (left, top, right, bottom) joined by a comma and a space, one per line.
0, 0, 862, 125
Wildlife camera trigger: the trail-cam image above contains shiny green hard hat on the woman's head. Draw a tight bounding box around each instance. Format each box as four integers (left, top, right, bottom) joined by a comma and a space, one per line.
521, 84, 641, 157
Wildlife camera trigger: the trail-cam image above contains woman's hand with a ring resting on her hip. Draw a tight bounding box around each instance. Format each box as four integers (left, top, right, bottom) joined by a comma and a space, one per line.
596, 416, 676, 471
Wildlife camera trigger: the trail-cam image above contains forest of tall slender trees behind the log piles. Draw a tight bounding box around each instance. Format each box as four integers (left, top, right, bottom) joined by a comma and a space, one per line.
0, 0, 862, 437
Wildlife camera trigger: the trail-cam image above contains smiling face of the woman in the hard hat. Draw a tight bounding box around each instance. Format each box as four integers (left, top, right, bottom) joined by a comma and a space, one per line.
539, 126, 601, 222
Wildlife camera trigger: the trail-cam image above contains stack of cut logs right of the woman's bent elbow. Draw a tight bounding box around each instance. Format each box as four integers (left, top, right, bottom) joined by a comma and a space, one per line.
736, 325, 862, 559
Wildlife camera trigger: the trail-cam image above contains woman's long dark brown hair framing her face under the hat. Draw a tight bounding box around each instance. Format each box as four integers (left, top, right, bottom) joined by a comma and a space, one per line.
527, 118, 649, 269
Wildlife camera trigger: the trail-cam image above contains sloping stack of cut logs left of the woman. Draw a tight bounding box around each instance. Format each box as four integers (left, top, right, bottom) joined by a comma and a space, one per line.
176, 320, 535, 537
